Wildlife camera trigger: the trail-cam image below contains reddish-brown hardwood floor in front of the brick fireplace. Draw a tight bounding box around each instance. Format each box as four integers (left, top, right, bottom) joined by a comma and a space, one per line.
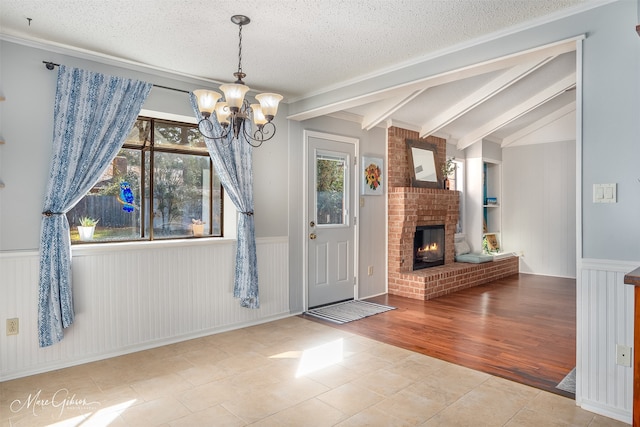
305, 274, 576, 398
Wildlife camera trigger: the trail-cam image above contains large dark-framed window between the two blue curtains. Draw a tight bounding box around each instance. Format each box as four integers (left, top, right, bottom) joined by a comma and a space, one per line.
67, 117, 223, 243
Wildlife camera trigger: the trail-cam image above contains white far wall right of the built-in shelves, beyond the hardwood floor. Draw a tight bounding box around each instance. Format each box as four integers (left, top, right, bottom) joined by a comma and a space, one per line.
501, 141, 576, 278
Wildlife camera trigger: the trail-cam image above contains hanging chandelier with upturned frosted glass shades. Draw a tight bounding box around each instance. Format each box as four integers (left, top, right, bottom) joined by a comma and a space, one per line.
193, 15, 282, 147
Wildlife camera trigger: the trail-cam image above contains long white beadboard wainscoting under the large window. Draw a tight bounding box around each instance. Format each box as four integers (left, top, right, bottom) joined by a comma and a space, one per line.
0, 237, 290, 381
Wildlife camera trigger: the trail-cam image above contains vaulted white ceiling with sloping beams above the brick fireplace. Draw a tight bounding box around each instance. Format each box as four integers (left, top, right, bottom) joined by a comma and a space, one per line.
316, 40, 576, 150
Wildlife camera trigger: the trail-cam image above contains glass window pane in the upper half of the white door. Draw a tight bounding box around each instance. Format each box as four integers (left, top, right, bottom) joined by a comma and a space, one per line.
316, 154, 347, 225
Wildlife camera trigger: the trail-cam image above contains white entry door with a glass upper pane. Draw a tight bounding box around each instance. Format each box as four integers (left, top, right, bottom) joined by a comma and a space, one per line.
305, 132, 357, 308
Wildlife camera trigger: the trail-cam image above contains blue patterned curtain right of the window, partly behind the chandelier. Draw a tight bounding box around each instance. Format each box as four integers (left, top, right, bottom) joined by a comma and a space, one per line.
190, 93, 260, 308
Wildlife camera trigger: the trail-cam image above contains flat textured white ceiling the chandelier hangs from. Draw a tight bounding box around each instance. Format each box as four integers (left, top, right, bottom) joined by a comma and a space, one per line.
0, 0, 592, 98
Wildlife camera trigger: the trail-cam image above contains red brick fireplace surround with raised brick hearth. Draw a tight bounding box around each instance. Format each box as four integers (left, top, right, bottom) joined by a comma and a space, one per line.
387, 127, 518, 300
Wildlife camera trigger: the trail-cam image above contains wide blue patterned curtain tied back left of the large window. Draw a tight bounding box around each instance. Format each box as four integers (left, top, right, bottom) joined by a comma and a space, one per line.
38, 65, 152, 347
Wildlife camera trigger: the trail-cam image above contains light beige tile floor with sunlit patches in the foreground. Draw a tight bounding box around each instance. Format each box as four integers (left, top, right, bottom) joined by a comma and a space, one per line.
0, 317, 626, 427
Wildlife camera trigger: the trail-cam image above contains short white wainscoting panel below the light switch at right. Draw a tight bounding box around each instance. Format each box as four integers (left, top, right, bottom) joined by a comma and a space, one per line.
576, 259, 639, 424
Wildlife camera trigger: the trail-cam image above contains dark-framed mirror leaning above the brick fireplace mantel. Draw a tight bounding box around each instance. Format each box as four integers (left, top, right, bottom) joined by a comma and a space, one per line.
407, 139, 442, 188
